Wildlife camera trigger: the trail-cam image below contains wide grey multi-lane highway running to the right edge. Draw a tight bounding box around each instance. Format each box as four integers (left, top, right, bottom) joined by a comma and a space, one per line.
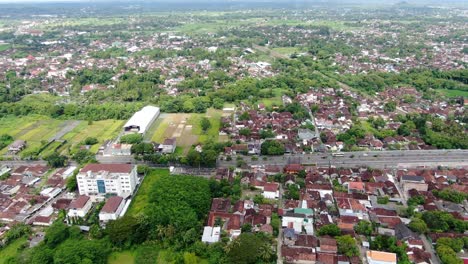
218, 150, 468, 168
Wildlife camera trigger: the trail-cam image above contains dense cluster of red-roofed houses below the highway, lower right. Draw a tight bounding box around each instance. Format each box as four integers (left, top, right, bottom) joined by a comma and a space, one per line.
213, 164, 468, 264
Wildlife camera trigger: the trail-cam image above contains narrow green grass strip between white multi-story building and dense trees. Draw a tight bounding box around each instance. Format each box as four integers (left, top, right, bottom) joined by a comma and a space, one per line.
127, 169, 169, 216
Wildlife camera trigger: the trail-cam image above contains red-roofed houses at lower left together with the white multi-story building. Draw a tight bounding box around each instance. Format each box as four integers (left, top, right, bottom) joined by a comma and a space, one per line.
0, 164, 140, 244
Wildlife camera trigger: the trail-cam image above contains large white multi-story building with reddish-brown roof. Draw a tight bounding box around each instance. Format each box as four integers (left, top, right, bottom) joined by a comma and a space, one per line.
76, 164, 138, 197
